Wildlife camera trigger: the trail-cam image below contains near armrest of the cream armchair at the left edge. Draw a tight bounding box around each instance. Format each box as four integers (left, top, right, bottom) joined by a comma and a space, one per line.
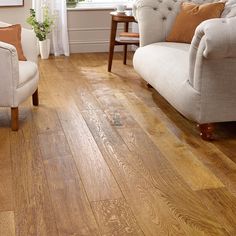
0, 41, 19, 106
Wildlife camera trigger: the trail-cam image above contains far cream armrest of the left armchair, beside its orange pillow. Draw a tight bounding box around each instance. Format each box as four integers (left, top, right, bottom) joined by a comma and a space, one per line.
21, 28, 39, 64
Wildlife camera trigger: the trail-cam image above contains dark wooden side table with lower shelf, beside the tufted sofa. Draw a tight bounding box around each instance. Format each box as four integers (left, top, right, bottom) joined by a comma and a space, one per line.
108, 11, 139, 72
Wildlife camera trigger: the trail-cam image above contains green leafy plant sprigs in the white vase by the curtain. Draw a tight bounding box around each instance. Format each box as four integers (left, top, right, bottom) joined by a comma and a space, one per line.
26, 6, 54, 41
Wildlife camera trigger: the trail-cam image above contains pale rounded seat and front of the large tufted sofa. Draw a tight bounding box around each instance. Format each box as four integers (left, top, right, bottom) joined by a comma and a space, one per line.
133, 42, 200, 120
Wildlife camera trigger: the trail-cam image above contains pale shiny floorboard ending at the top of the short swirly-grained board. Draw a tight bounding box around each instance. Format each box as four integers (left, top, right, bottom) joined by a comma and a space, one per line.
58, 100, 123, 201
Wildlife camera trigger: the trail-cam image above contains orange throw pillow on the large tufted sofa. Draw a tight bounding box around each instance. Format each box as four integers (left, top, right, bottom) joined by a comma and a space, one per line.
166, 2, 225, 43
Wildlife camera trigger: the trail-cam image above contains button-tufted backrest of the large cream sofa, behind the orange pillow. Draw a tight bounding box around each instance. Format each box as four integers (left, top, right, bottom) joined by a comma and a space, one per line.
133, 0, 236, 46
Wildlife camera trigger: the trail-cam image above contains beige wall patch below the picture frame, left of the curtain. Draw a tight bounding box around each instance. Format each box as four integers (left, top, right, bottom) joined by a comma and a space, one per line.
0, 0, 32, 28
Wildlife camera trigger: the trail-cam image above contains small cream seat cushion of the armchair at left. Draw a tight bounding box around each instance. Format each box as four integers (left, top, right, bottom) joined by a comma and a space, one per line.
18, 61, 38, 87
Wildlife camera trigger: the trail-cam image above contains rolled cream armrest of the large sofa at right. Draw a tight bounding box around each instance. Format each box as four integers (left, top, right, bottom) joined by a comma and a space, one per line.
189, 17, 236, 90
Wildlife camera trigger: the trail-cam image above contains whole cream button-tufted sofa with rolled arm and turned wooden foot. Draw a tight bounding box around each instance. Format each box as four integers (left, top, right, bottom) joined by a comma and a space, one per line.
133, 0, 236, 139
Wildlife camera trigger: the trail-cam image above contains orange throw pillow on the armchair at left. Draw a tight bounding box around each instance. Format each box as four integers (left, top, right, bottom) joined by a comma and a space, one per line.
0, 24, 26, 61
